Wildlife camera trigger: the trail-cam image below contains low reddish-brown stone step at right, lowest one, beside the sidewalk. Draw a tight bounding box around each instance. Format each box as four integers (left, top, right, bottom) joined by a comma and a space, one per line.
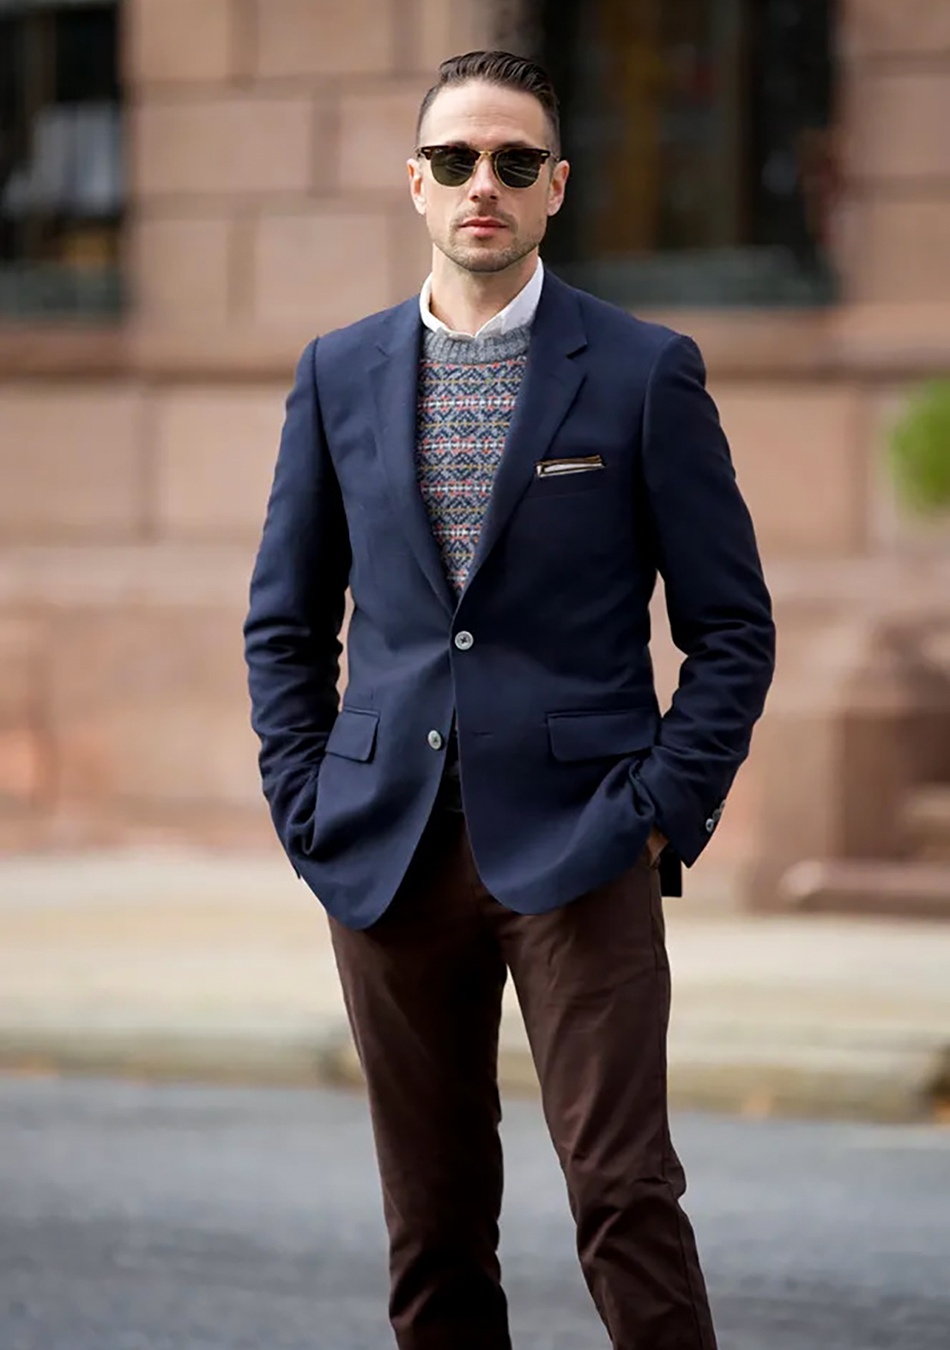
779, 859, 950, 919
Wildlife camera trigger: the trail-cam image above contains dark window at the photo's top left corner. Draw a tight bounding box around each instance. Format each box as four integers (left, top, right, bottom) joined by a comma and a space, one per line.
0, 0, 123, 317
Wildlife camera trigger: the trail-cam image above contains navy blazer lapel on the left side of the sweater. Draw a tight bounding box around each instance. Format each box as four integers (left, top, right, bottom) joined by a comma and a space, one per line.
368, 300, 455, 613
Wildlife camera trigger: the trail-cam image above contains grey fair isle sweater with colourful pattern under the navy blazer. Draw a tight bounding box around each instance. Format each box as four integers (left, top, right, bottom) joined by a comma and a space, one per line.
416, 324, 530, 597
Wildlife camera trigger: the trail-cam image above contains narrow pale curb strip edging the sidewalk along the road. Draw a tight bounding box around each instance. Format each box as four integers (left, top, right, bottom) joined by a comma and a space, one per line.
0, 1022, 950, 1123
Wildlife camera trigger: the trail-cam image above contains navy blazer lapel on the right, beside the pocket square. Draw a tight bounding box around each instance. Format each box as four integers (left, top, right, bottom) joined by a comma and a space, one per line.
466, 269, 587, 590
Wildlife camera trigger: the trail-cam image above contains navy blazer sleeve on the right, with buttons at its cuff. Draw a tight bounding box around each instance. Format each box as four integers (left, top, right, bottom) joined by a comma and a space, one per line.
633, 335, 775, 865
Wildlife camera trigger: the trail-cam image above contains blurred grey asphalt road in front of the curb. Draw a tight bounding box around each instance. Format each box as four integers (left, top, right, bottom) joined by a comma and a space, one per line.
0, 1079, 950, 1350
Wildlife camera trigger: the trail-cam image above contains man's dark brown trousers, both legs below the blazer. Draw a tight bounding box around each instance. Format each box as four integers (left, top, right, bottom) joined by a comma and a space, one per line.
331, 809, 715, 1350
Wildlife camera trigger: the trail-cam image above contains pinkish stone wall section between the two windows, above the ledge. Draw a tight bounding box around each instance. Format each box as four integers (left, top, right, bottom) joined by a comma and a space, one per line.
127, 0, 491, 342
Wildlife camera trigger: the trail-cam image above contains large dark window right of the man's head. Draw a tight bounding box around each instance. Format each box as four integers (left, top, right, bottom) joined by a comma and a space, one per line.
529, 0, 835, 305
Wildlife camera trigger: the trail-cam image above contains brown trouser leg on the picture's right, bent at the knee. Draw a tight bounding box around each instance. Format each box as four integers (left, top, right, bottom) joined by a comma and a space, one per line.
497, 853, 715, 1350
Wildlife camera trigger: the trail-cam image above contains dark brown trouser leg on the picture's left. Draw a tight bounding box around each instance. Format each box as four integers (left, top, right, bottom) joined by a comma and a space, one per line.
331, 814, 510, 1350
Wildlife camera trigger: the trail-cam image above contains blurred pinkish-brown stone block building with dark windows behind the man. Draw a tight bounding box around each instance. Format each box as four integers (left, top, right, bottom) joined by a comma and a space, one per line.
0, 0, 950, 903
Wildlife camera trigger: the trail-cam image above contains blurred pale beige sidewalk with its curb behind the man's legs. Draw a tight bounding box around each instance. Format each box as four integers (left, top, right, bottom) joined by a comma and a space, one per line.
0, 852, 950, 1121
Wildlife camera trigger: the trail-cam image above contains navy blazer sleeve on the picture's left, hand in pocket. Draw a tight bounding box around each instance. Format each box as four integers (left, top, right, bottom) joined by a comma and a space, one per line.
244, 339, 351, 861
